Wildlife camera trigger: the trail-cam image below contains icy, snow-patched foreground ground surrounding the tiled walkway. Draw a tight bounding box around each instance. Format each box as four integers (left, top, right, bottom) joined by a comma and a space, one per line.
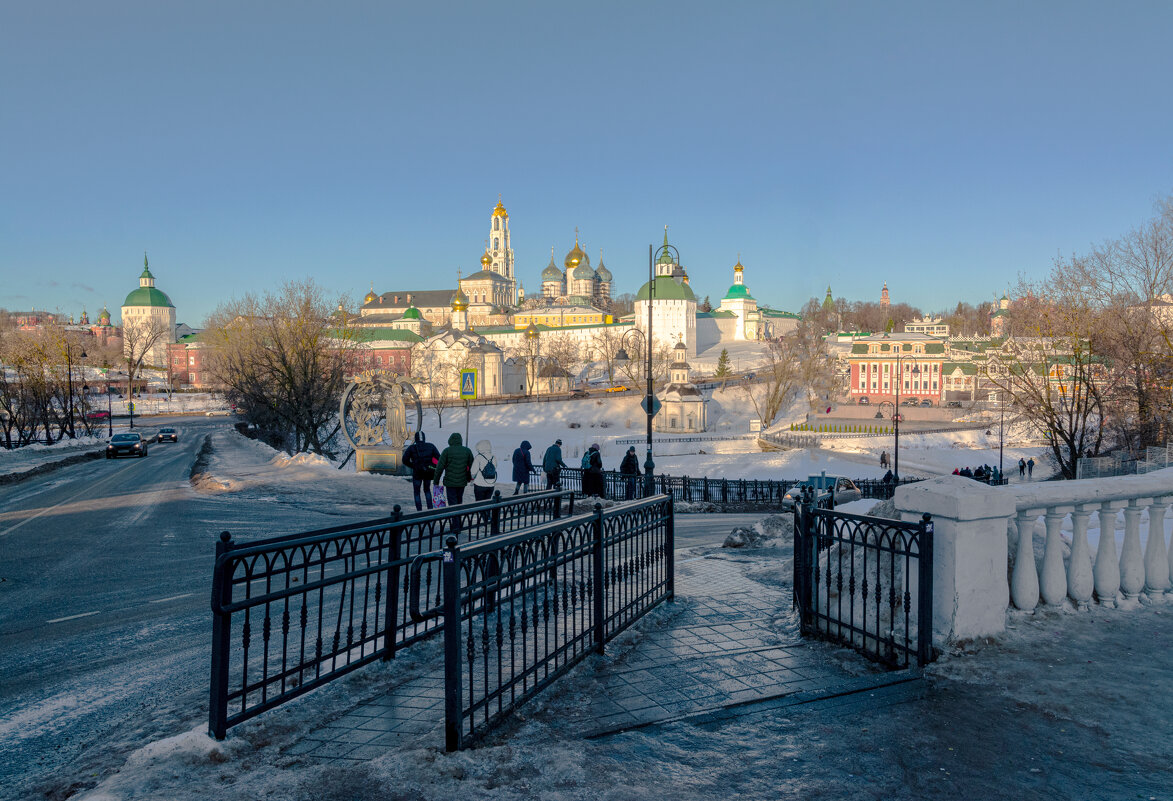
75, 541, 1173, 801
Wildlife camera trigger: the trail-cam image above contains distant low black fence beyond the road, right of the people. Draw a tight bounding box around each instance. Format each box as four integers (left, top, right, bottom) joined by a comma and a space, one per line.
561, 467, 923, 508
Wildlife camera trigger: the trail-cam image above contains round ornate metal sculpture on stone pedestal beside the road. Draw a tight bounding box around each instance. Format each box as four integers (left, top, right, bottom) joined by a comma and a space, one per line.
338, 369, 423, 474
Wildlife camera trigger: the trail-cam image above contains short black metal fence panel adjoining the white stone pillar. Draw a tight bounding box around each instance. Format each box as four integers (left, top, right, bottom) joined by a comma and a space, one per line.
794, 503, 933, 667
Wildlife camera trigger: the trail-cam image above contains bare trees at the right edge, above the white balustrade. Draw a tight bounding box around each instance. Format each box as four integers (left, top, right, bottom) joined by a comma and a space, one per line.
990, 198, 1173, 478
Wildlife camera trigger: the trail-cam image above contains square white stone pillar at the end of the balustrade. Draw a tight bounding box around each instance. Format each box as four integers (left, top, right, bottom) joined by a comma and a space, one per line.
895, 476, 1015, 645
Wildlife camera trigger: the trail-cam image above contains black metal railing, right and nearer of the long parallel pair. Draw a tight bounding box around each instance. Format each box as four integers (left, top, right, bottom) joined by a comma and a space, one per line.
438, 496, 674, 751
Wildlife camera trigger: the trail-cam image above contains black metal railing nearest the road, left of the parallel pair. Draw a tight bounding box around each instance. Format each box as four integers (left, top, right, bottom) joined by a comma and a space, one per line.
209, 491, 574, 739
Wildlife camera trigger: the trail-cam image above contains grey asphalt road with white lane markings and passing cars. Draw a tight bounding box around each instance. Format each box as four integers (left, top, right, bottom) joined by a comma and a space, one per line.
0, 431, 759, 799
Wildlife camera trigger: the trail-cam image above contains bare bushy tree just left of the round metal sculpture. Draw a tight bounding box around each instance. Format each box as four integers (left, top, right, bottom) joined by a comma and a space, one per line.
204, 280, 355, 456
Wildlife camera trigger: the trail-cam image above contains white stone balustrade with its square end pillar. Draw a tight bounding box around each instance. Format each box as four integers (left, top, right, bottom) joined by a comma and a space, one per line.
895, 468, 1173, 645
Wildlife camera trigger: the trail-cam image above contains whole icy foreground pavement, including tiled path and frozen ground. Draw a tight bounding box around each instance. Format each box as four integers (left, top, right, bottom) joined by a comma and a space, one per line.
75, 525, 1173, 801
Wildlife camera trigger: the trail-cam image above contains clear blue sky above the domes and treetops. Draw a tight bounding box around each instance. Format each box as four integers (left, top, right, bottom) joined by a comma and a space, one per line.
0, 0, 1173, 325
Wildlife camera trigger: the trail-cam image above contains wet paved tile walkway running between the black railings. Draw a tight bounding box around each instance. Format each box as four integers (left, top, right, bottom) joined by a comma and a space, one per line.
289, 552, 882, 762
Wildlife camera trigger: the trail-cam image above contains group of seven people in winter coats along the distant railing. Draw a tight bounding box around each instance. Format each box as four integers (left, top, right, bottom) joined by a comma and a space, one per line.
402, 432, 639, 511
